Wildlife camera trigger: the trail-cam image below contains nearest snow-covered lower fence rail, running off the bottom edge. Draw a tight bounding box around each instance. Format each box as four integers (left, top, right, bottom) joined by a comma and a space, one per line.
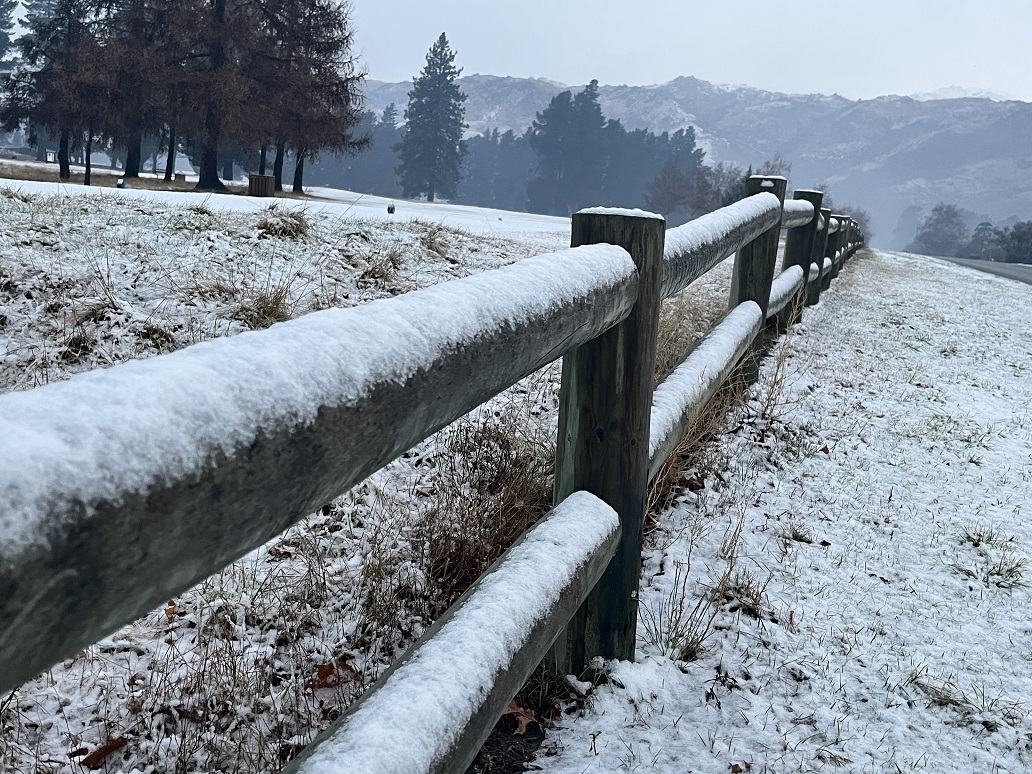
288, 492, 620, 774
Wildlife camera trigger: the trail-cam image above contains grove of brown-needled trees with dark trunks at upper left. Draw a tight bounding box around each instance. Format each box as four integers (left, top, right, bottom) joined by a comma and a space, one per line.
0, 0, 364, 190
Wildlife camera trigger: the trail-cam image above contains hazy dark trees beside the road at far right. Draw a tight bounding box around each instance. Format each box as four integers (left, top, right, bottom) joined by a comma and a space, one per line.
906, 201, 1032, 263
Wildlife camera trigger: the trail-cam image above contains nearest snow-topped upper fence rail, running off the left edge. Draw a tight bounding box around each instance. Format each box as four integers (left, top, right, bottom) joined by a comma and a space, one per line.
0, 245, 638, 691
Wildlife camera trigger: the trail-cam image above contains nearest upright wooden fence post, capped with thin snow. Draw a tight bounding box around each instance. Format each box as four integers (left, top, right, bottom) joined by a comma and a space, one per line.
548, 209, 666, 675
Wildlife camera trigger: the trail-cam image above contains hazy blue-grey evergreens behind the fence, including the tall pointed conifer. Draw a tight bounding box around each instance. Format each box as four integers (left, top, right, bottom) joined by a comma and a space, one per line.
313, 34, 869, 228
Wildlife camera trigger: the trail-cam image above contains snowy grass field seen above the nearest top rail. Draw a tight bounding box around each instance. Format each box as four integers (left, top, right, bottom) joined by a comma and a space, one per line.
0, 182, 569, 390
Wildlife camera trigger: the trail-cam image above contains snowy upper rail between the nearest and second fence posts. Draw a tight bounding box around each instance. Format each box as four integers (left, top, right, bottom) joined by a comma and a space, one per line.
662, 192, 781, 298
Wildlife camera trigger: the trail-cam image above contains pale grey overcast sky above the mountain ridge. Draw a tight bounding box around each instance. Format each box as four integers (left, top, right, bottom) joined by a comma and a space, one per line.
352, 0, 1032, 101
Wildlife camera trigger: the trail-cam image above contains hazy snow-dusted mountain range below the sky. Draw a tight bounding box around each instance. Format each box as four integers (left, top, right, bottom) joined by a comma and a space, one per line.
364, 75, 1032, 248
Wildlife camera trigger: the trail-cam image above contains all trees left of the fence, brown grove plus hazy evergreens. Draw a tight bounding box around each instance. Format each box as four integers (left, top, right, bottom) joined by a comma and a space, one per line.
0, 13, 879, 232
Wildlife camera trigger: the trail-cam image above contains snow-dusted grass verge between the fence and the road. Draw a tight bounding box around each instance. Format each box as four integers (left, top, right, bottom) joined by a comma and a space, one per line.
537, 253, 1032, 774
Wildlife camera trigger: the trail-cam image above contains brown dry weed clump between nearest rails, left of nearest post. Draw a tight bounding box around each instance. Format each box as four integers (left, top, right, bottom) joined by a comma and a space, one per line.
362, 409, 554, 638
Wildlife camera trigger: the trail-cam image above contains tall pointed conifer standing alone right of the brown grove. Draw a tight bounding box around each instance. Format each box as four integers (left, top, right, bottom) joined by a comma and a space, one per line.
397, 32, 465, 201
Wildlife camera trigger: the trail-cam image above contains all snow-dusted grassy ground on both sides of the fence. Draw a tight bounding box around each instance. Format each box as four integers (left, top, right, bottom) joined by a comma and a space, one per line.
0, 182, 1032, 774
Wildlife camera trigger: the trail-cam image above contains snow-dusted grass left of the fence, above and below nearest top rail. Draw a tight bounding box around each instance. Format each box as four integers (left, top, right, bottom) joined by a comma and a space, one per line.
0, 181, 573, 772
